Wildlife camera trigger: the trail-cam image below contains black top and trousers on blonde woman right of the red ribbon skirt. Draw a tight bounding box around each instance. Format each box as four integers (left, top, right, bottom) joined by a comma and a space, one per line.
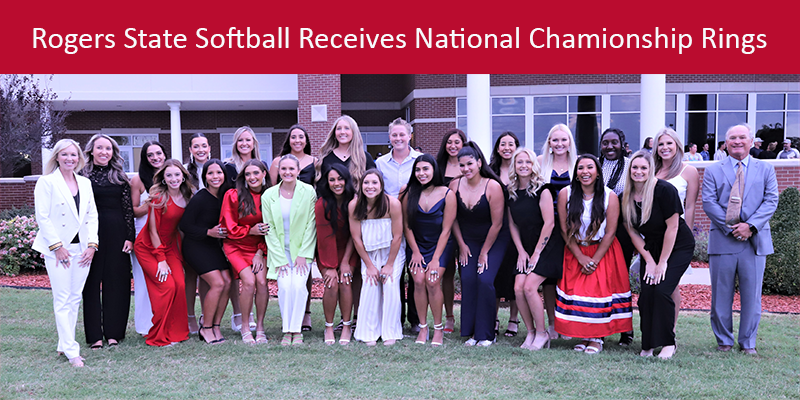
636, 179, 694, 350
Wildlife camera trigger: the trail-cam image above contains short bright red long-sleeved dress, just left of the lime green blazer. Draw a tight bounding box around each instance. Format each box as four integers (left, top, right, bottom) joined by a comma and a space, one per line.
219, 189, 267, 279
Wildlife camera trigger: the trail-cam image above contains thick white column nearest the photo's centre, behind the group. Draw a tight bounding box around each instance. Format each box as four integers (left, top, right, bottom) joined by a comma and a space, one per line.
467, 74, 492, 155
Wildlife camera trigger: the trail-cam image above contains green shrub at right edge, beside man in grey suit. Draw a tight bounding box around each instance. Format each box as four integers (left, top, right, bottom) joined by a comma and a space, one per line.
762, 187, 800, 295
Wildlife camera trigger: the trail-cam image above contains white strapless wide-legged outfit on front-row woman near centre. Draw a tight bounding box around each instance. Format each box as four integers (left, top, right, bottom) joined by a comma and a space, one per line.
354, 218, 406, 342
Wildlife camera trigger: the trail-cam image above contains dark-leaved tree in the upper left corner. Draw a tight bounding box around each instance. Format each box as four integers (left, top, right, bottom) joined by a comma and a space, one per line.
0, 75, 69, 177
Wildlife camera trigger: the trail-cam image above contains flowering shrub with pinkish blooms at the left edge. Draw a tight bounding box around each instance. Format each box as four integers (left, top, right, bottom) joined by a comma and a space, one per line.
0, 216, 44, 275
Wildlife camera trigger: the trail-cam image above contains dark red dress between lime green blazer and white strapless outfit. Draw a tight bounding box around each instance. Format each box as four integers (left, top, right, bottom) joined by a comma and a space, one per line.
314, 199, 360, 270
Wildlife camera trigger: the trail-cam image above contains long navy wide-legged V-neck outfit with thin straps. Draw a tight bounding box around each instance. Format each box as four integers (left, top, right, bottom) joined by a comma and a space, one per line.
456, 181, 508, 340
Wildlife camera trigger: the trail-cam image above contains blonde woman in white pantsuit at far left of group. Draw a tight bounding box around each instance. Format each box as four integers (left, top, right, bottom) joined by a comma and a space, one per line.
33, 139, 98, 367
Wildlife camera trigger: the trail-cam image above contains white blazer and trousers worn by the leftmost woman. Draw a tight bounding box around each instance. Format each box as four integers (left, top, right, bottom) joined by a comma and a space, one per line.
32, 169, 99, 359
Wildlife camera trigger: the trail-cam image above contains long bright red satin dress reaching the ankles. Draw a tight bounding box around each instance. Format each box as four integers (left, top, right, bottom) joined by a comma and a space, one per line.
133, 196, 189, 346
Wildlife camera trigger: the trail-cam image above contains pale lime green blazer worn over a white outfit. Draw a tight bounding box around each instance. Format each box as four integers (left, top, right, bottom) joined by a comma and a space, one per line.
261, 181, 317, 279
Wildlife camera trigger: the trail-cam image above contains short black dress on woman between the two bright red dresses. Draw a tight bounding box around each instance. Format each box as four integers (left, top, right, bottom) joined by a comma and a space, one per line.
180, 189, 230, 275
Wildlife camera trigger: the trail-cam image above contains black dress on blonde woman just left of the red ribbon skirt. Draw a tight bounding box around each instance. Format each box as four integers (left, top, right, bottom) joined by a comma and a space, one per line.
508, 184, 564, 279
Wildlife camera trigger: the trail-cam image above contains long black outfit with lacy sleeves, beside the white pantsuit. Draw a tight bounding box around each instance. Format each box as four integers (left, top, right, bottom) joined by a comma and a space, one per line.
83, 165, 136, 344
